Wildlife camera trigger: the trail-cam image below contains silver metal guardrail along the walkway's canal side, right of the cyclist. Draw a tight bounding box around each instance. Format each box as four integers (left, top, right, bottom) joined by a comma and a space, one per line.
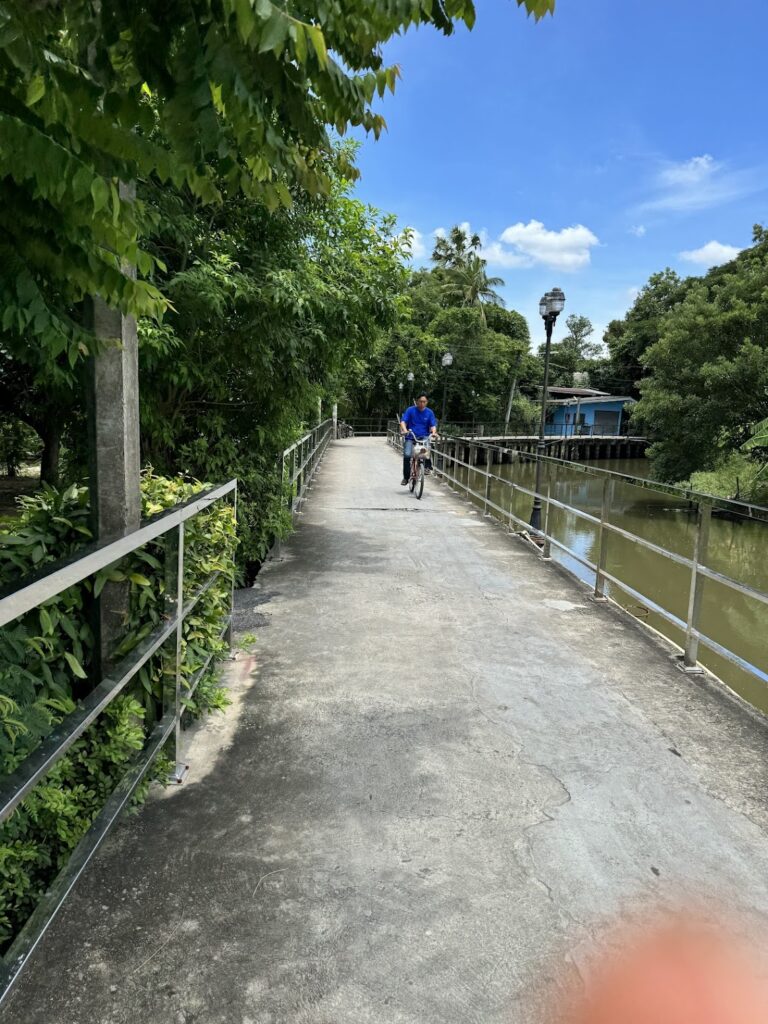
387, 430, 768, 683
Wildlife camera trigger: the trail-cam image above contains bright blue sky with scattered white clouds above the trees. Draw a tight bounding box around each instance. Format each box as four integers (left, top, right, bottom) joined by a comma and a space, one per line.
357, 0, 768, 341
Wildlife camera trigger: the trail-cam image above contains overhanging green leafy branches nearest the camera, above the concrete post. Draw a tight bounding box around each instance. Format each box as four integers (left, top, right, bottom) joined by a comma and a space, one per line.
0, 0, 554, 364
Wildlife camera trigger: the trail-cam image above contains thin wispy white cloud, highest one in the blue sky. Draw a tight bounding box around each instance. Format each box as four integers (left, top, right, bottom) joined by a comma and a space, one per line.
639, 153, 766, 213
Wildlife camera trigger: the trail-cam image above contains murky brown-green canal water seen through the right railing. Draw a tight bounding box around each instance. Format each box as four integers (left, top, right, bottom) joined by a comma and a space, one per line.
460, 459, 768, 712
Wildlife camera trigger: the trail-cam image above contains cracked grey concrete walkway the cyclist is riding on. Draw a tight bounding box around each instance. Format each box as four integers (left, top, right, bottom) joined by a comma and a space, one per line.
5, 439, 768, 1024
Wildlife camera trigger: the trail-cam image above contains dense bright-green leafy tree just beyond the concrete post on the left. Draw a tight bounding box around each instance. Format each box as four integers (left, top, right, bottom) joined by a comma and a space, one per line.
140, 149, 407, 574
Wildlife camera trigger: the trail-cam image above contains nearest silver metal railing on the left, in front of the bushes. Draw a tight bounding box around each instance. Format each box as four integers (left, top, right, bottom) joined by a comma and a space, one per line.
0, 480, 238, 1002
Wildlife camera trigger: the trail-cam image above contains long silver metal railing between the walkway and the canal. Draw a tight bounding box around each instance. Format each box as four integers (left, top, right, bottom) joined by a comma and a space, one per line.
387, 430, 768, 683
